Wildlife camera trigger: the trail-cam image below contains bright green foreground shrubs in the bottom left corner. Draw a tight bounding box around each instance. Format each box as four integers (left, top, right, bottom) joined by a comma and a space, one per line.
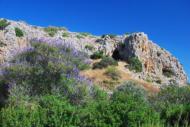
0, 95, 80, 127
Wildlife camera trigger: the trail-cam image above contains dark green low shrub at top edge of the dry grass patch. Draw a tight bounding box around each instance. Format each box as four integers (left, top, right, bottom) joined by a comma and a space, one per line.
93, 57, 118, 69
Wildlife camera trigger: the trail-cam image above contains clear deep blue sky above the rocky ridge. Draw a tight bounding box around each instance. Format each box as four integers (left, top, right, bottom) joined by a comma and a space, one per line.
0, 0, 190, 81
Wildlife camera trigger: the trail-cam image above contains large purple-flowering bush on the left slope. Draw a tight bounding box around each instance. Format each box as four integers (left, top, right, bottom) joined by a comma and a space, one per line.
1, 41, 92, 103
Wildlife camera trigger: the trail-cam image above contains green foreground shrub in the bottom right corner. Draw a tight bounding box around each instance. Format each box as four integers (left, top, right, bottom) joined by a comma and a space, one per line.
150, 85, 190, 126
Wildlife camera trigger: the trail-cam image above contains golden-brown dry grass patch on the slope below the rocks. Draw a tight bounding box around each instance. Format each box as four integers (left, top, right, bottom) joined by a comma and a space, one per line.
81, 60, 159, 93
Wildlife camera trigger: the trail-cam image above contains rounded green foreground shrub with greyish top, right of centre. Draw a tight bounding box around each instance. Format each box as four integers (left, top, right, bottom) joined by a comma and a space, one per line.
112, 82, 159, 127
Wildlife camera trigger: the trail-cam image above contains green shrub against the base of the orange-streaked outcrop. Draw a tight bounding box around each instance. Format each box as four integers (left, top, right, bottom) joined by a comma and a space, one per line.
128, 57, 142, 72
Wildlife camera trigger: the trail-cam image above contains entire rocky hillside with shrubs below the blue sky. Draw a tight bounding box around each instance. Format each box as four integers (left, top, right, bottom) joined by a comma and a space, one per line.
0, 19, 190, 127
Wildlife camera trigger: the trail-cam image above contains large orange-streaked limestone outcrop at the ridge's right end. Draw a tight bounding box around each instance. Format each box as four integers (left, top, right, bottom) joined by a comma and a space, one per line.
119, 33, 187, 85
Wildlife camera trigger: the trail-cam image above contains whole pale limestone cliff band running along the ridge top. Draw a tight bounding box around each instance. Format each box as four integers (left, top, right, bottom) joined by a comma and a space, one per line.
0, 20, 187, 85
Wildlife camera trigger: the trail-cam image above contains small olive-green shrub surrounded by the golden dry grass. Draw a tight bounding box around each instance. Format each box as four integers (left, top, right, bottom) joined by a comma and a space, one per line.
105, 66, 121, 80
